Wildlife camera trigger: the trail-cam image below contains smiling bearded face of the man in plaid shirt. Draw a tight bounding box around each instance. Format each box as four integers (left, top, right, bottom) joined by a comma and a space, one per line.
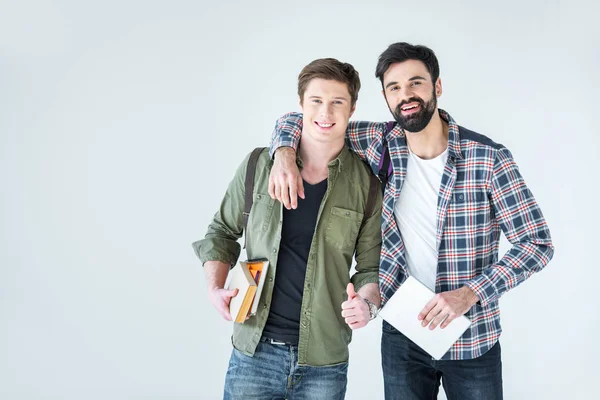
383, 60, 442, 132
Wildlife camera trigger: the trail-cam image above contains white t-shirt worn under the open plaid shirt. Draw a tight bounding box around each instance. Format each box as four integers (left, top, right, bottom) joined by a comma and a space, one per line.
394, 149, 448, 291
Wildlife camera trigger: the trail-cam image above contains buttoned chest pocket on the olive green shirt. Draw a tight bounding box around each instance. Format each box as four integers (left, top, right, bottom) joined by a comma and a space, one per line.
325, 207, 364, 249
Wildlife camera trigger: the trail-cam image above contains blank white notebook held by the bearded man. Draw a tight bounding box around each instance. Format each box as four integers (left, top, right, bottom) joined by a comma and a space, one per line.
379, 276, 471, 360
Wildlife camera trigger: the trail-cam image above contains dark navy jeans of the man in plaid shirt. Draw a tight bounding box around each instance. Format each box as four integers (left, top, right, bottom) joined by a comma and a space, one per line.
381, 321, 502, 400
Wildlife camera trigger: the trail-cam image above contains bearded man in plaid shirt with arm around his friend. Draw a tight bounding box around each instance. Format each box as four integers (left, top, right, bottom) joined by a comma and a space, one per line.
269, 43, 554, 400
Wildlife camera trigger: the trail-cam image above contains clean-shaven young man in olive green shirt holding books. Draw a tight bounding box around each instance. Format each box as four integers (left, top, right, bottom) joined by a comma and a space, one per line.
194, 59, 382, 399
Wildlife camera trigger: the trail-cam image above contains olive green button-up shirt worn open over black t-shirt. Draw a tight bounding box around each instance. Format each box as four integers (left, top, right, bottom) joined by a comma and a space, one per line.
193, 147, 381, 366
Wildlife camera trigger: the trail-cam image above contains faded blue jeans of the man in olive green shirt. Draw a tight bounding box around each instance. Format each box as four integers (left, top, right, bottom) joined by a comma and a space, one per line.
223, 341, 348, 400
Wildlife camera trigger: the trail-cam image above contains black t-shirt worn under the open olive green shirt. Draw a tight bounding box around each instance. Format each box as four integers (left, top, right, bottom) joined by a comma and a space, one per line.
263, 179, 327, 345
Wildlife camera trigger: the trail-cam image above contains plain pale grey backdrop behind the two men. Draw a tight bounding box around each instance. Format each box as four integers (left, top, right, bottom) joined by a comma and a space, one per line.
0, 0, 600, 400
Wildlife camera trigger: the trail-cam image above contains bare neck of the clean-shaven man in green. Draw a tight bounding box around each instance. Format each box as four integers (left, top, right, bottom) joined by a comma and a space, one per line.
298, 135, 344, 184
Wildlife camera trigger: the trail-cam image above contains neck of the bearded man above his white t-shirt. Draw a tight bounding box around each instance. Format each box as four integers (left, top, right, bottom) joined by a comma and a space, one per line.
405, 109, 448, 160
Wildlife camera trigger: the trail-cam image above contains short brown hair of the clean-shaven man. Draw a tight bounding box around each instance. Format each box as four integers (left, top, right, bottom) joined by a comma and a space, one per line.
298, 58, 360, 107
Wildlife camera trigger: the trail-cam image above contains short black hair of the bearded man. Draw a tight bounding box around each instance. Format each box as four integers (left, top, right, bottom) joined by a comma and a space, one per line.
375, 42, 440, 86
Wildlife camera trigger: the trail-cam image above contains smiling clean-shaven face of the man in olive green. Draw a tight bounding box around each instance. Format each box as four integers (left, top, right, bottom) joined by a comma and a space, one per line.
300, 78, 355, 143
